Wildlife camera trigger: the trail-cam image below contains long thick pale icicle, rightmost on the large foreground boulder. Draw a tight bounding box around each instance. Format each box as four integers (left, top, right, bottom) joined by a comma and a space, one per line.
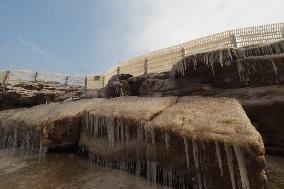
234, 145, 250, 189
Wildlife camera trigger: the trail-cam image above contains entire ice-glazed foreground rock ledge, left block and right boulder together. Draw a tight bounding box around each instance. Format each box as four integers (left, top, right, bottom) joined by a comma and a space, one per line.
0, 97, 266, 189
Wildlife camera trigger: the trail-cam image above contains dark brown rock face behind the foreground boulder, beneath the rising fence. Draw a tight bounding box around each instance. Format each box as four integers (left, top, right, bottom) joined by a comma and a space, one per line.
107, 41, 284, 154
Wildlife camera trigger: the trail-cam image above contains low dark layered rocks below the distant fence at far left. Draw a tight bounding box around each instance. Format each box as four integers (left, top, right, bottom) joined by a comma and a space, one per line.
0, 82, 83, 110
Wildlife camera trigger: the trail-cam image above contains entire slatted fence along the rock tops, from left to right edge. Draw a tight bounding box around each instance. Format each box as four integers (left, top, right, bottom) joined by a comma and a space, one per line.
0, 23, 284, 89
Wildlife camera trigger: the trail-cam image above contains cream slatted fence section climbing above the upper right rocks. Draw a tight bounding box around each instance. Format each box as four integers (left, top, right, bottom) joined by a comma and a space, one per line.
104, 23, 284, 84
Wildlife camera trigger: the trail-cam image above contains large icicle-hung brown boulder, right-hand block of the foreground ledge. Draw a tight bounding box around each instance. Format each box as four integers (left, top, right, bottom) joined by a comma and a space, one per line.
80, 97, 266, 188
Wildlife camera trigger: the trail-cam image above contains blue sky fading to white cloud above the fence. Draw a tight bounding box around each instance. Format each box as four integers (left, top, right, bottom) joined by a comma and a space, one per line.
0, 0, 284, 74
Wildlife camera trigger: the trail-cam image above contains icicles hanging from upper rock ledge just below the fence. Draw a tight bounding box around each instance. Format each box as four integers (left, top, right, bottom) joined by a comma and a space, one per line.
171, 40, 284, 84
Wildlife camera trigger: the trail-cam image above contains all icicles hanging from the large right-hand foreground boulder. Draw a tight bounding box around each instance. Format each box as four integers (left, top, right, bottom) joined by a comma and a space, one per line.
80, 113, 250, 189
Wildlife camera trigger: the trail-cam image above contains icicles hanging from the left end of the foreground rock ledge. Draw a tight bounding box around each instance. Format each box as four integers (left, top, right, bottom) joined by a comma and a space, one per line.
0, 122, 48, 156
